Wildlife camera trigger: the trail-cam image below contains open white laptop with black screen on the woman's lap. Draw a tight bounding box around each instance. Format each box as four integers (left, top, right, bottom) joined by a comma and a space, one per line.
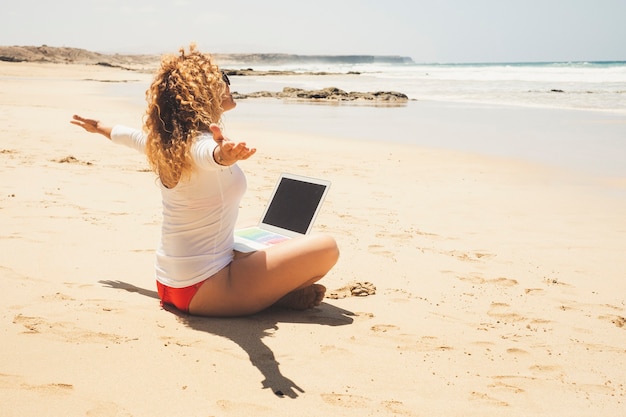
234, 173, 330, 252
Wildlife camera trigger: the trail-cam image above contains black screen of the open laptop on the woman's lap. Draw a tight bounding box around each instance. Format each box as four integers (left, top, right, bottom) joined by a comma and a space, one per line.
263, 178, 326, 234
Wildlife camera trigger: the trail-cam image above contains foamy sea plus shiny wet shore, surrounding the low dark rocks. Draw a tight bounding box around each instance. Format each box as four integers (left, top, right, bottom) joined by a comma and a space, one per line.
111, 61, 626, 178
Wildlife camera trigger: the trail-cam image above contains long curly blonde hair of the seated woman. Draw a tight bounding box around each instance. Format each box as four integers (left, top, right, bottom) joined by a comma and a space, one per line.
144, 44, 226, 188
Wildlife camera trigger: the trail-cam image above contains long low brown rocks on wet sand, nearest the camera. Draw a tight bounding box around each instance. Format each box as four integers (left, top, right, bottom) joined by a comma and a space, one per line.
233, 87, 409, 104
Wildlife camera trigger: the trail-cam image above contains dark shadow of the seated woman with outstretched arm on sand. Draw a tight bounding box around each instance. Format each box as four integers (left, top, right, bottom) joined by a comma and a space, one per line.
99, 281, 355, 398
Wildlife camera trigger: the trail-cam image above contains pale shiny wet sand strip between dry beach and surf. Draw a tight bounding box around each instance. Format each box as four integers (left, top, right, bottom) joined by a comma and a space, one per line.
226, 100, 626, 180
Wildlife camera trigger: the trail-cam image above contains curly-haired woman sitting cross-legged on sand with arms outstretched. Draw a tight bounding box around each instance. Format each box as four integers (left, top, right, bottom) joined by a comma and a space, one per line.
71, 44, 339, 316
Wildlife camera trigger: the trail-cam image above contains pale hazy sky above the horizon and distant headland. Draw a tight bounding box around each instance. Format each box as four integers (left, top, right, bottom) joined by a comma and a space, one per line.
0, 0, 626, 63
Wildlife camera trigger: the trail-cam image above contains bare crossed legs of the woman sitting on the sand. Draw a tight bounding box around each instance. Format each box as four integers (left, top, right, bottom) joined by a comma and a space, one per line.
189, 234, 339, 316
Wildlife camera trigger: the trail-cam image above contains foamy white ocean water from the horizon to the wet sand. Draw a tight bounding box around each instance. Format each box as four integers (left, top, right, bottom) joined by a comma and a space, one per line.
227, 61, 626, 115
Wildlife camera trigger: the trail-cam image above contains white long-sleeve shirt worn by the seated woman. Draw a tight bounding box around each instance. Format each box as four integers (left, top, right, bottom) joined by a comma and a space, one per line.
111, 125, 246, 288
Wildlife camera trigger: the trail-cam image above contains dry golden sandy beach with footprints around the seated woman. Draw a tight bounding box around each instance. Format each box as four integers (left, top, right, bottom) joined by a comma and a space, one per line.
0, 62, 626, 417
